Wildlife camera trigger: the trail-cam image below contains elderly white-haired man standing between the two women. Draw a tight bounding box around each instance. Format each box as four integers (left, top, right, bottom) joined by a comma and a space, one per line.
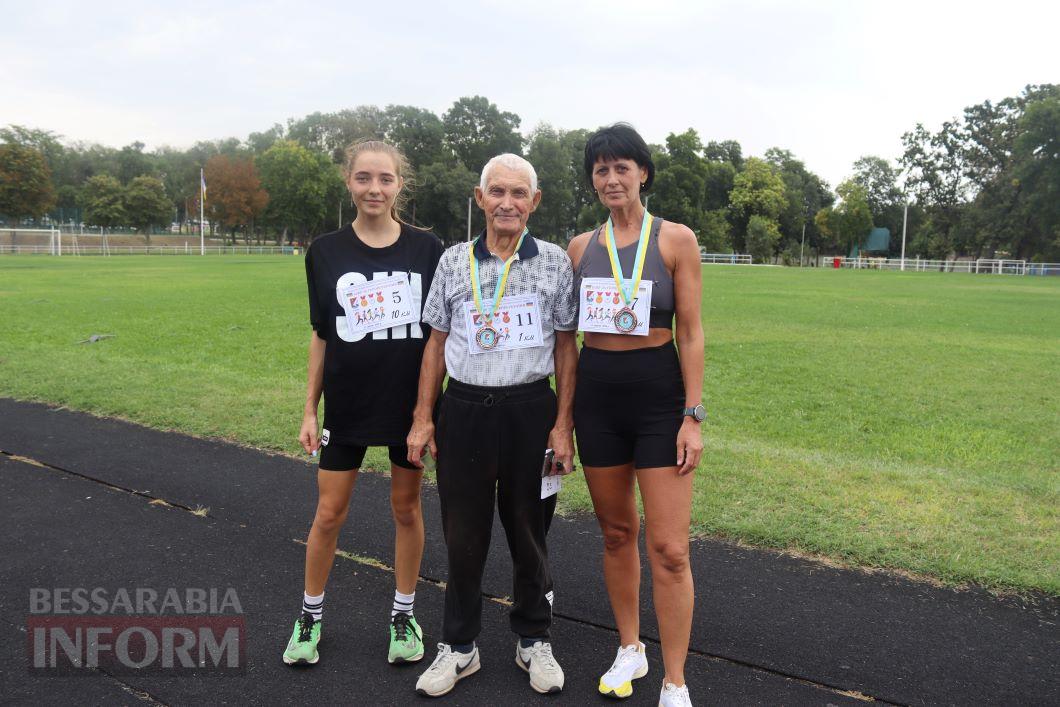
408, 155, 578, 696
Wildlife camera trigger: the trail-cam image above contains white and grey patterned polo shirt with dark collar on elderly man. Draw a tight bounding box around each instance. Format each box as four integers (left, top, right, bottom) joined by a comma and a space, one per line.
423, 233, 578, 387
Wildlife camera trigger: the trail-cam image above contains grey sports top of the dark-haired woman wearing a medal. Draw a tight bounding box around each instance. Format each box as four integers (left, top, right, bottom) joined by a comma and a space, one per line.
575, 216, 673, 329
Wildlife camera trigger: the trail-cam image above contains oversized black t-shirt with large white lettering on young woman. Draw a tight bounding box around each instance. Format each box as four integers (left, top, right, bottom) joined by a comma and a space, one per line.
305, 224, 444, 446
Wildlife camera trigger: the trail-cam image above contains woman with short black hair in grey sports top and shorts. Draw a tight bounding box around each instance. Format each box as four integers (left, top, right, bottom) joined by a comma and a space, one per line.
567, 123, 705, 707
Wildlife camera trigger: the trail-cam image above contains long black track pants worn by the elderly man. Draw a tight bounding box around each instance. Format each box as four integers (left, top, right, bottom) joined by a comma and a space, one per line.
436, 378, 557, 643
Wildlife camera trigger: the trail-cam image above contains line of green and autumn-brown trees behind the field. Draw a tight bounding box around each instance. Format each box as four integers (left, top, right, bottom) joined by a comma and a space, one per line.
0, 85, 1060, 262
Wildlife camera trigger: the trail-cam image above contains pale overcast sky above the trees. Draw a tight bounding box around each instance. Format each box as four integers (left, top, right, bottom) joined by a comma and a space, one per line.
0, 0, 1060, 187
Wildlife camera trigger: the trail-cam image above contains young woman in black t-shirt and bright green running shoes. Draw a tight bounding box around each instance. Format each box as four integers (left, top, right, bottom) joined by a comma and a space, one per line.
283, 141, 443, 665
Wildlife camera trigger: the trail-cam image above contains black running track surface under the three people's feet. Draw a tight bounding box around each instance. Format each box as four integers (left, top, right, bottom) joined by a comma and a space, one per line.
0, 400, 1060, 705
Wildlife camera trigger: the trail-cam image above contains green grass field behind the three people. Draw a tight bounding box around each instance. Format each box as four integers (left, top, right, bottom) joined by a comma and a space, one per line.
0, 257, 1060, 595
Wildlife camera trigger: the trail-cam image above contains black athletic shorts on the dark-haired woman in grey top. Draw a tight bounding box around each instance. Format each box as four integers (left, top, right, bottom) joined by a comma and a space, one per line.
575, 341, 685, 469
